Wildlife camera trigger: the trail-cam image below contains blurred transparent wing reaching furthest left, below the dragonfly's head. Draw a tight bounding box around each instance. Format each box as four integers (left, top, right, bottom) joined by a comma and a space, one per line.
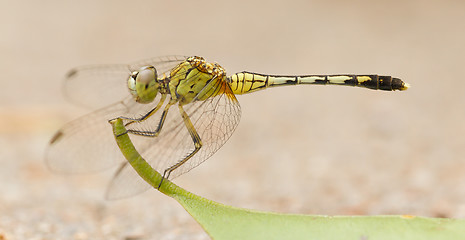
45, 93, 164, 173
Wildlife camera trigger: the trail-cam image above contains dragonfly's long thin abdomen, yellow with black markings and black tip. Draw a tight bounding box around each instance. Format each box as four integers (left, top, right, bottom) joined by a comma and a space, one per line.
228, 72, 409, 94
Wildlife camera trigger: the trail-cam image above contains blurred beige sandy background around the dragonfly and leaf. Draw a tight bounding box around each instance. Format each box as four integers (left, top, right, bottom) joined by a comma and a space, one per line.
0, 0, 465, 239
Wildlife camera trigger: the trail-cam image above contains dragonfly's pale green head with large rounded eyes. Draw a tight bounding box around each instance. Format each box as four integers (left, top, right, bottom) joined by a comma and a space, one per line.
128, 66, 159, 103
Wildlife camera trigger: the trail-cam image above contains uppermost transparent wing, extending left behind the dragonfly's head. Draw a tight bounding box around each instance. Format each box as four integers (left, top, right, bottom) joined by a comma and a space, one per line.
63, 56, 187, 109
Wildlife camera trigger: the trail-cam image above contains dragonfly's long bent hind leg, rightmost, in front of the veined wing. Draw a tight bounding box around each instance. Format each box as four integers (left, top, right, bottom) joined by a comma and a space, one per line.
158, 104, 202, 188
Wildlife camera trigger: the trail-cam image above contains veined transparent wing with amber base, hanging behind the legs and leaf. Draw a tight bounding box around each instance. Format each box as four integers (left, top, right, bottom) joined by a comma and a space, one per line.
107, 80, 241, 199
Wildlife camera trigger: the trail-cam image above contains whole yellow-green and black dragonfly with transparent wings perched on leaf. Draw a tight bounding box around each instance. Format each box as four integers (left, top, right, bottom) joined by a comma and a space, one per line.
46, 56, 409, 199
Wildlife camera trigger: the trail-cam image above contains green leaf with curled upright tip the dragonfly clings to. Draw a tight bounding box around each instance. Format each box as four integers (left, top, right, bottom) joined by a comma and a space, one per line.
110, 119, 465, 240
